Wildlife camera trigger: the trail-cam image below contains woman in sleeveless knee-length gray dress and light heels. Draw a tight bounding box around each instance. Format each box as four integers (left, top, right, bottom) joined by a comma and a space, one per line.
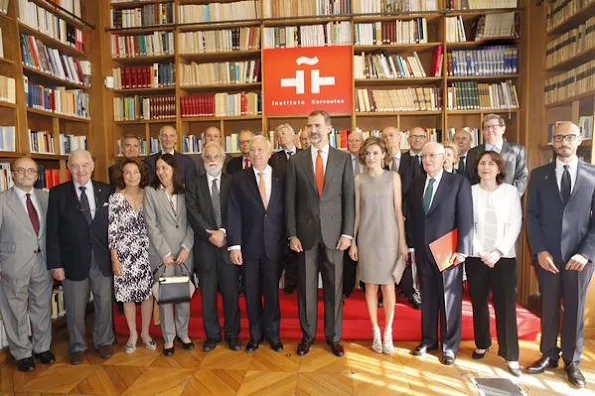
349, 137, 407, 354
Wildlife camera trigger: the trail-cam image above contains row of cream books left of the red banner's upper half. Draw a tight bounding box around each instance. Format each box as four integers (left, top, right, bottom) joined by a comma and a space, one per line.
180, 59, 260, 87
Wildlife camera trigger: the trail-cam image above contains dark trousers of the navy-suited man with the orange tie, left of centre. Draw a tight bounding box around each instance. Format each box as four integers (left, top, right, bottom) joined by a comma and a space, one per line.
243, 257, 281, 342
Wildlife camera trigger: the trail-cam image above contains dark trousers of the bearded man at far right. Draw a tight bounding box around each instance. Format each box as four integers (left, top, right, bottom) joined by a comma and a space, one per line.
535, 262, 594, 364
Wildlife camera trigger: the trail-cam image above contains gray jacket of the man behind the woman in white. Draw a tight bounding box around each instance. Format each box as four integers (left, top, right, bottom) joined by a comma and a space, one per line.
465, 142, 529, 195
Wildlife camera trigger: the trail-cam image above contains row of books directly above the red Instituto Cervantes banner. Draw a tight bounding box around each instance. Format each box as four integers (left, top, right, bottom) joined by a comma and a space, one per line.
264, 21, 352, 48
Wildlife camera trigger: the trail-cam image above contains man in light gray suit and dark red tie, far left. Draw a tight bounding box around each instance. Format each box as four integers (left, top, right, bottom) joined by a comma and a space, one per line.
0, 157, 55, 372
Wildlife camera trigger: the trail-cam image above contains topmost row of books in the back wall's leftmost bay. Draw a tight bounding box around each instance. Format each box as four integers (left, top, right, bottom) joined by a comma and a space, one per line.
110, 2, 176, 29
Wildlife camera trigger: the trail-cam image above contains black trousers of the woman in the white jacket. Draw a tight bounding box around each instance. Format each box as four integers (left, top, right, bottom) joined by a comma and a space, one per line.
465, 257, 519, 361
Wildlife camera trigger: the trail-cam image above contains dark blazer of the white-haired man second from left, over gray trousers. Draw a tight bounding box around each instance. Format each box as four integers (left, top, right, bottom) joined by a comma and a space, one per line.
46, 181, 113, 281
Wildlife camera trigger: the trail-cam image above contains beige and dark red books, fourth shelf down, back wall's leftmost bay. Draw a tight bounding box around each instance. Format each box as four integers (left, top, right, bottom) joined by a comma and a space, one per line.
114, 95, 176, 121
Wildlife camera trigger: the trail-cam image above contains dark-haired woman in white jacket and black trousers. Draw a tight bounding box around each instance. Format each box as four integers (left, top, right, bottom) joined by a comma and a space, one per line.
465, 151, 522, 376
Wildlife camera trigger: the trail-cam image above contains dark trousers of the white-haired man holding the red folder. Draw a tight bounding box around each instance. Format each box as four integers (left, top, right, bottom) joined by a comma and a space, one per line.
418, 262, 463, 356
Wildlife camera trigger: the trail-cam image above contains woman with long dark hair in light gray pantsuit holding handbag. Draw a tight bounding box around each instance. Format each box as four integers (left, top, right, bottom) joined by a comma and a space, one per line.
144, 154, 194, 356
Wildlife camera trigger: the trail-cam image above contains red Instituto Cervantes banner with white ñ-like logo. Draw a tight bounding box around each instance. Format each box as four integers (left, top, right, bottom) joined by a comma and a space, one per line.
262, 46, 353, 117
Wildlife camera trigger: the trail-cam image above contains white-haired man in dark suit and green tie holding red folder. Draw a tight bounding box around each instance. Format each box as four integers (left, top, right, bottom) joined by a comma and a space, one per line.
406, 142, 473, 365
